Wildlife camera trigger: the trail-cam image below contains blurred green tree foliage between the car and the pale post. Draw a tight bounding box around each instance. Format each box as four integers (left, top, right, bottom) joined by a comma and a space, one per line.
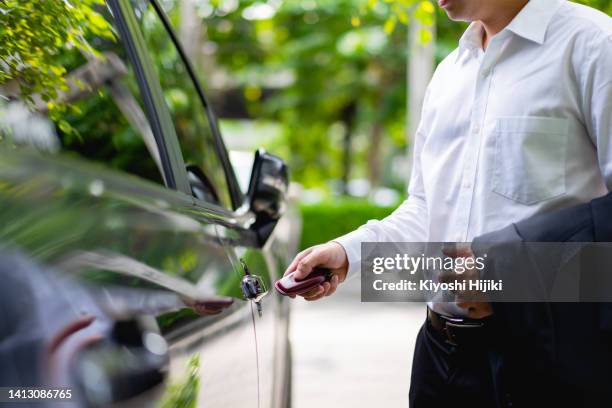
192, 0, 407, 187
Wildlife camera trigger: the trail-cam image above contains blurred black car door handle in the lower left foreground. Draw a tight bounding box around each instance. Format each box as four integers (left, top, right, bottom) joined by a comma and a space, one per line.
73, 317, 169, 407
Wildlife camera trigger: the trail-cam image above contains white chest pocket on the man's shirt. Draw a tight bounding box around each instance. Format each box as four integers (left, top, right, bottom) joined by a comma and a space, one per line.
492, 116, 569, 205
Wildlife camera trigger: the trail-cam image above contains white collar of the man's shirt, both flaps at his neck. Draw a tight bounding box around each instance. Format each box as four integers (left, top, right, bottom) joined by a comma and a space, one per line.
457, 0, 564, 60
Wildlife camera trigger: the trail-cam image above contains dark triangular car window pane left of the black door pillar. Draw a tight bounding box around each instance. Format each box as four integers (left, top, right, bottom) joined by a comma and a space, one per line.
43, 6, 163, 184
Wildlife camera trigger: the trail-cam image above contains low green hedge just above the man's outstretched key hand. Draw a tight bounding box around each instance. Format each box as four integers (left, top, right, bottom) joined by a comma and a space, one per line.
300, 198, 396, 250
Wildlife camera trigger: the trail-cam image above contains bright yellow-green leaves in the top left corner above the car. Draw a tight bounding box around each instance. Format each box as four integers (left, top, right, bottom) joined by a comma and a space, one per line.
0, 0, 110, 113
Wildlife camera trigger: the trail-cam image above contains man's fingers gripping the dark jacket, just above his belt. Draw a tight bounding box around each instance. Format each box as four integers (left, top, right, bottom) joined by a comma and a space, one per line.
440, 246, 493, 319
